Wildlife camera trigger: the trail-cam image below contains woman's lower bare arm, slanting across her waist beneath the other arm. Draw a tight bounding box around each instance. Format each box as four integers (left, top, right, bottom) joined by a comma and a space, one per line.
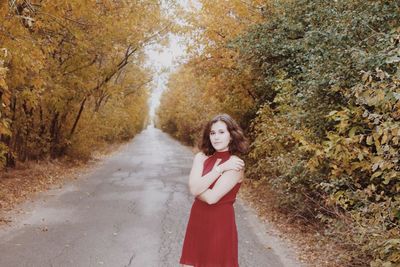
197, 169, 244, 205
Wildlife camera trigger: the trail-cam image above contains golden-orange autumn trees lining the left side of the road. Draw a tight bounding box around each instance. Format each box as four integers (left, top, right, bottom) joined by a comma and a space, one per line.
0, 0, 166, 166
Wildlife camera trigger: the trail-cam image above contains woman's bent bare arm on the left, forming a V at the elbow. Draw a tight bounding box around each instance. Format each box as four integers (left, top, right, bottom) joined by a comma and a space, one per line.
189, 152, 220, 196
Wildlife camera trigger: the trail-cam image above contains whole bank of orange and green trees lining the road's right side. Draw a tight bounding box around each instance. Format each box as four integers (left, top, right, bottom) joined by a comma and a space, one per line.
157, 0, 400, 267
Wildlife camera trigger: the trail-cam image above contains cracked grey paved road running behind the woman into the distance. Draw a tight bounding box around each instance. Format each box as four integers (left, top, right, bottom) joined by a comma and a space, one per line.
0, 126, 300, 267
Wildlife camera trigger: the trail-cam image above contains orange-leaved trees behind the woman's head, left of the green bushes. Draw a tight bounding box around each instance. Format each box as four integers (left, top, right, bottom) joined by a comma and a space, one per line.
159, 0, 261, 143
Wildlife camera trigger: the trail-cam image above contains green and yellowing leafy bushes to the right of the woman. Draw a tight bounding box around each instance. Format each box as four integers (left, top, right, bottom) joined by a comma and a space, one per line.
233, 0, 400, 263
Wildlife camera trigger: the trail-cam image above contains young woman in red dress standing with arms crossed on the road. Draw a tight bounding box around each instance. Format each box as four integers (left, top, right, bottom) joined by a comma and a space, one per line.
179, 114, 248, 267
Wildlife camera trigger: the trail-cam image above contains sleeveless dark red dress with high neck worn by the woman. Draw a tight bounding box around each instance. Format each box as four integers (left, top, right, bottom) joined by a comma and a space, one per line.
179, 151, 241, 267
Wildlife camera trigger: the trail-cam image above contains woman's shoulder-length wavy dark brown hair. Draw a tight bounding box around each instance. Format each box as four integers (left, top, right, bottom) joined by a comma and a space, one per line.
198, 113, 249, 155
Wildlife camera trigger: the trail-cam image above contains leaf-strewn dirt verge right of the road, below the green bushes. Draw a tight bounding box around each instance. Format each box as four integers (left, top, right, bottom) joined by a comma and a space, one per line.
238, 179, 346, 267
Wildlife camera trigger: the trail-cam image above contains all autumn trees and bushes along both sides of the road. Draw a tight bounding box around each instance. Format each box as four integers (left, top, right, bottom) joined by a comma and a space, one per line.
0, 0, 400, 267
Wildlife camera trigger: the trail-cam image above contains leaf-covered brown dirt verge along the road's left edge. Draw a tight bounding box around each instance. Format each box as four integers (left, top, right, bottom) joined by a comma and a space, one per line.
0, 143, 126, 226
